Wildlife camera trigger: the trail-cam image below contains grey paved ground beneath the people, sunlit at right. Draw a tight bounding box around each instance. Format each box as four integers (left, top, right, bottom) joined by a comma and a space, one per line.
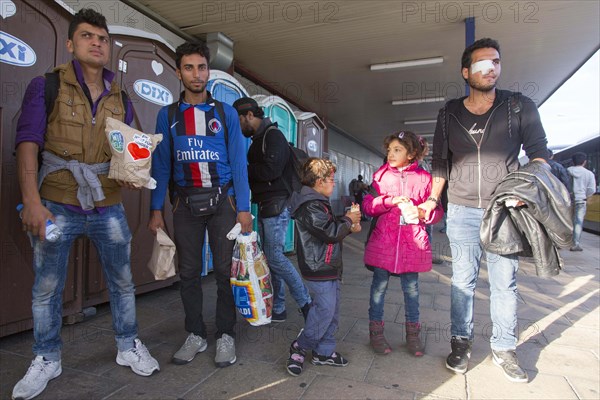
0, 223, 600, 400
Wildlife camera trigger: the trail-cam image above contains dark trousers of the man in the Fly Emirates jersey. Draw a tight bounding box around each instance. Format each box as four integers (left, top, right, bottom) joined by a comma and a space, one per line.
173, 196, 237, 339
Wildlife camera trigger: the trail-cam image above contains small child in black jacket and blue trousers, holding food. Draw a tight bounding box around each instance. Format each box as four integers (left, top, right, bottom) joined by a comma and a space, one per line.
287, 158, 360, 376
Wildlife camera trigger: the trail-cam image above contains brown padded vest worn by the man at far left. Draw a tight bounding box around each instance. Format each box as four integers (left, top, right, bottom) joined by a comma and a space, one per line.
40, 63, 125, 207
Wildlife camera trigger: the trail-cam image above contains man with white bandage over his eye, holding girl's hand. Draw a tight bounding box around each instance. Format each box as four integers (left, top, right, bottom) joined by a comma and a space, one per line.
419, 39, 548, 382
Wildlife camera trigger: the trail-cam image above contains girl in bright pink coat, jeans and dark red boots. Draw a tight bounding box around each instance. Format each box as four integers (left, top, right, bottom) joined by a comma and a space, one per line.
363, 131, 443, 357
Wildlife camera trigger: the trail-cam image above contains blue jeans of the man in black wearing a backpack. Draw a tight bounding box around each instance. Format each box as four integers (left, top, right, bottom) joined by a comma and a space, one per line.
258, 208, 310, 314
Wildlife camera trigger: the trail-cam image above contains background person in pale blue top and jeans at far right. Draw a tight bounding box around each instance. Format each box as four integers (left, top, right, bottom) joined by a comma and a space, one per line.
568, 152, 596, 251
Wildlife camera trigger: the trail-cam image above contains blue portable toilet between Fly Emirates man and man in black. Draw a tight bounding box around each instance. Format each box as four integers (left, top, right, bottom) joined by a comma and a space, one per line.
202, 69, 250, 276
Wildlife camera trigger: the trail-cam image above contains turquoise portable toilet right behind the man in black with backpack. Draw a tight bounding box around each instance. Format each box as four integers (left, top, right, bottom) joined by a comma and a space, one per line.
252, 94, 298, 253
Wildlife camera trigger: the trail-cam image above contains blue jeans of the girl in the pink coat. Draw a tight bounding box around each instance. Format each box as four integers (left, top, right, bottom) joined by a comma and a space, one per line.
369, 267, 419, 322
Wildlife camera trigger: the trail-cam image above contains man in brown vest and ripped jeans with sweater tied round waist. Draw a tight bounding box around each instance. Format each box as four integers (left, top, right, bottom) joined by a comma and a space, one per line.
12, 9, 159, 399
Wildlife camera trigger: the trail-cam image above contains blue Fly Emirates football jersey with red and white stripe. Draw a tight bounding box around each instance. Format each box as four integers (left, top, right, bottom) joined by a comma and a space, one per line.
150, 96, 250, 212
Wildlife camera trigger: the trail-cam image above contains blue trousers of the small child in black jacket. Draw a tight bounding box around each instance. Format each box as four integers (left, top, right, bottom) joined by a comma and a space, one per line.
297, 279, 342, 356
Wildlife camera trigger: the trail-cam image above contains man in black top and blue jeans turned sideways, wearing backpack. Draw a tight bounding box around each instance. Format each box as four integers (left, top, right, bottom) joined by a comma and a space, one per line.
233, 97, 310, 322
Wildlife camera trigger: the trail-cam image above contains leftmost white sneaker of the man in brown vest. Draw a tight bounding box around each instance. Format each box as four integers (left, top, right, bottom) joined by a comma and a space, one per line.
12, 356, 62, 400
